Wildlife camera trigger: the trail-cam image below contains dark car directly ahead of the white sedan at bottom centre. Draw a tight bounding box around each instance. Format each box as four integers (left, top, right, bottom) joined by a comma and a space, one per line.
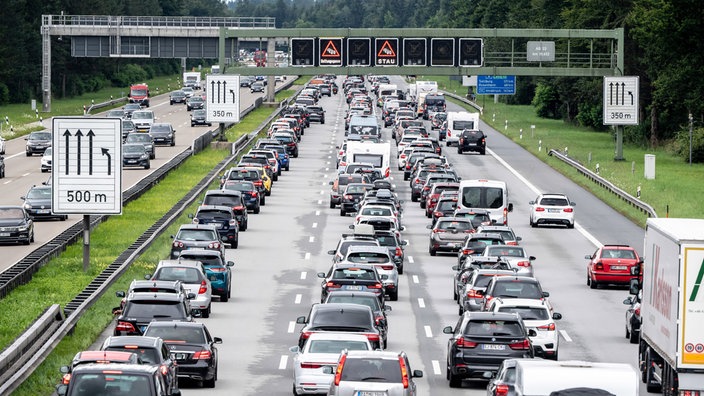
296, 303, 384, 349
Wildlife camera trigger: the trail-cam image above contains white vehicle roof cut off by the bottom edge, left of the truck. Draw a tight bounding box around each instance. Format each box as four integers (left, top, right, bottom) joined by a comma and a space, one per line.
489, 359, 639, 396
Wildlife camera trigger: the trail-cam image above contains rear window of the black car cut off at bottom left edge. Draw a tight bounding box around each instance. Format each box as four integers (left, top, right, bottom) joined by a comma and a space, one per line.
71, 370, 154, 396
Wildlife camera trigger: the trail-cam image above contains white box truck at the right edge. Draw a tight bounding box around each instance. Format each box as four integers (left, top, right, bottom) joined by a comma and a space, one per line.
630, 218, 704, 395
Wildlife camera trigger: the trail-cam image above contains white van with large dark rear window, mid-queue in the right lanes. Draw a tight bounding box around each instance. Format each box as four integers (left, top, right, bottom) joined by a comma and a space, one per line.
457, 179, 513, 225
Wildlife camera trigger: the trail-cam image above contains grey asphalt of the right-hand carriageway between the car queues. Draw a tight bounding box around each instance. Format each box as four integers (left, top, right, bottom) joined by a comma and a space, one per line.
106, 77, 645, 396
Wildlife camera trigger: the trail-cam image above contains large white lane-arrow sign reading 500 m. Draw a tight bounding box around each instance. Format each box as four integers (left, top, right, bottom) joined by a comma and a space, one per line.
51, 117, 122, 215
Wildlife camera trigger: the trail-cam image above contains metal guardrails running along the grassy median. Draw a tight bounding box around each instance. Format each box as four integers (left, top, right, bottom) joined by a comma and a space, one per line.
0, 76, 300, 394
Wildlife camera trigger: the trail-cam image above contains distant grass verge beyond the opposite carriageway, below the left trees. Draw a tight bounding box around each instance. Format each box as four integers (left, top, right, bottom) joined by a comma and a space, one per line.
0, 74, 181, 139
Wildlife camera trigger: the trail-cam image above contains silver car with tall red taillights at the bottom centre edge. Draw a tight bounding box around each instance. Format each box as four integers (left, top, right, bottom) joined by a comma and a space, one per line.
325, 351, 423, 396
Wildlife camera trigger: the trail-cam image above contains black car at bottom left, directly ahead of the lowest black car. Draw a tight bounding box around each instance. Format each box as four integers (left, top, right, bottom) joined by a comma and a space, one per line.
100, 336, 181, 396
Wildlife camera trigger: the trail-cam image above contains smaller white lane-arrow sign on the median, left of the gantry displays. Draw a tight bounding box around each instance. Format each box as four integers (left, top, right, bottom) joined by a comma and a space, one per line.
205, 74, 240, 122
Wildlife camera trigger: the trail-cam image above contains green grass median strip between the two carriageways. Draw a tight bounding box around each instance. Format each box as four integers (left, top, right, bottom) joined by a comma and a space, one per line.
5, 96, 286, 396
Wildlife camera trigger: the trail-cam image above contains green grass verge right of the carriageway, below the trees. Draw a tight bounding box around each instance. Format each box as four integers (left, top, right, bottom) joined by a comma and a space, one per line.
420, 77, 704, 225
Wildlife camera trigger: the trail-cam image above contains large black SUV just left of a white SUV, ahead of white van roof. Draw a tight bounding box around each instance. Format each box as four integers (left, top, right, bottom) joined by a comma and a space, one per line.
443, 312, 537, 388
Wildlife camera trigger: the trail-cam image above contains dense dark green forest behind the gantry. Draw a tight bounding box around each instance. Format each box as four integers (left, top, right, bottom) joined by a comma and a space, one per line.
0, 0, 704, 155
